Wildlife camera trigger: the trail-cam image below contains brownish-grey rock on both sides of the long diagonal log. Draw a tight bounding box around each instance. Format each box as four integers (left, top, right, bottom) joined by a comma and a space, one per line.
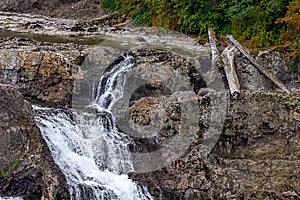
227, 48, 300, 92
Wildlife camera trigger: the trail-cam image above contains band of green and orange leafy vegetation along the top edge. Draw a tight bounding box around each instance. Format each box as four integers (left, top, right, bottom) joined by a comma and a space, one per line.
101, 0, 300, 55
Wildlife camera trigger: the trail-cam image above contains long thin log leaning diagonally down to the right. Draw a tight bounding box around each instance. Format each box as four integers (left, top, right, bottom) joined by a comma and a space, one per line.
227, 35, 291, 94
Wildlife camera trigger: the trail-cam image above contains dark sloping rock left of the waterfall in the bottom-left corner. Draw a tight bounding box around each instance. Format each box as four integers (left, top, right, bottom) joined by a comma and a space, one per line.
0, 84, 68, 199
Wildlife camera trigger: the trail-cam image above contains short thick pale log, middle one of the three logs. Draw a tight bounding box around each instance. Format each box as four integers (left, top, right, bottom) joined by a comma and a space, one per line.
221, 45, 241, 99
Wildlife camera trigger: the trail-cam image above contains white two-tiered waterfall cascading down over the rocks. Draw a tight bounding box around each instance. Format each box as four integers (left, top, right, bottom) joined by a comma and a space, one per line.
34, 55, 152, 200
